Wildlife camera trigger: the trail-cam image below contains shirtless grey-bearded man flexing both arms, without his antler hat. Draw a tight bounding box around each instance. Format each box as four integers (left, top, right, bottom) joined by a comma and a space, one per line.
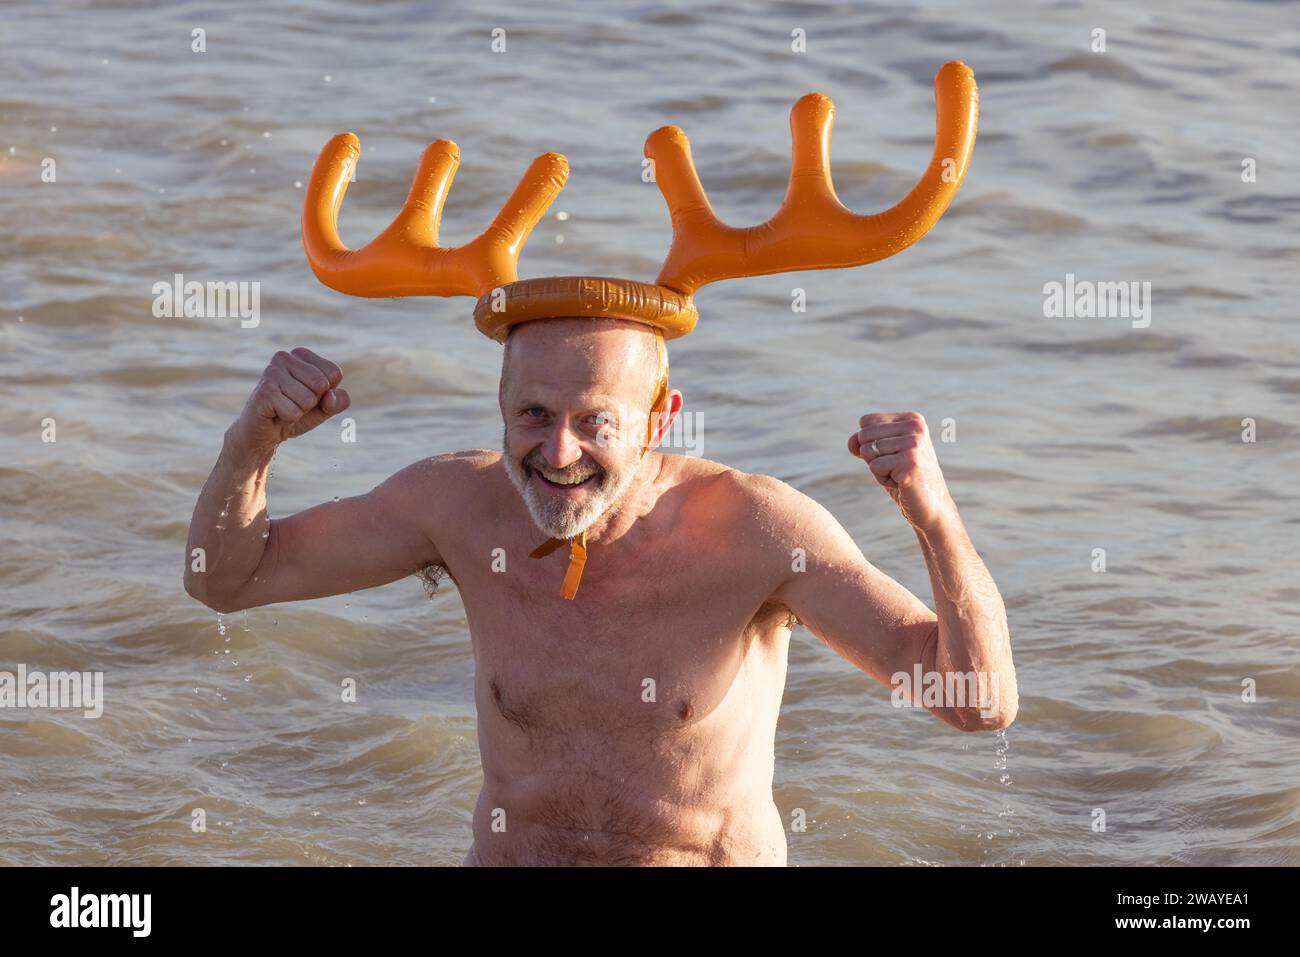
185, 319, 1017, 866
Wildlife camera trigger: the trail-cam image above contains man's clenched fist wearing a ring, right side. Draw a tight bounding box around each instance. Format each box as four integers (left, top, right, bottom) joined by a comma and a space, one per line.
849, 412, 957, 531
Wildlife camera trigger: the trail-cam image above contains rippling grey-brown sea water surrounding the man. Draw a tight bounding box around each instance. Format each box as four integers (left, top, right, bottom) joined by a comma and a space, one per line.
0, 0, 1300, 866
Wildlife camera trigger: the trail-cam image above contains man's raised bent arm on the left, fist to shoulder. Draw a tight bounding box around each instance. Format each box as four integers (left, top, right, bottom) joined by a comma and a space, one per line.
185, 350, 445, 612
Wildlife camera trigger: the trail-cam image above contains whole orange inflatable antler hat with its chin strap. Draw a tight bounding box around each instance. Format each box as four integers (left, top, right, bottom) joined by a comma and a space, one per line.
303, 60, 979, 598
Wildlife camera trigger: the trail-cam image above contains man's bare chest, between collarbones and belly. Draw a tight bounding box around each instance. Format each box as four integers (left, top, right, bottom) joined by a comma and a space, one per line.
462, 527, 789, 750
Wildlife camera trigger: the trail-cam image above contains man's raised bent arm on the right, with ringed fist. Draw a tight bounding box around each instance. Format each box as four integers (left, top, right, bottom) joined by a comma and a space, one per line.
774, 412, 1018, 731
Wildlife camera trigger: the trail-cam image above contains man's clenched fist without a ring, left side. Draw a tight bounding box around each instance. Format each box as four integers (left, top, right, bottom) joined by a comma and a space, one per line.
226, 347, 352, 458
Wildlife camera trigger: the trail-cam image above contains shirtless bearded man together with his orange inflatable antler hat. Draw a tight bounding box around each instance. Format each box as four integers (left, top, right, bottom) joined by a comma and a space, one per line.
186, 61, 1017, 865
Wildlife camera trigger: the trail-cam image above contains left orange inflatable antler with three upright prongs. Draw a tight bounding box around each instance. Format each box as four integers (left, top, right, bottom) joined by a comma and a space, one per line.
303, 133, 568, 296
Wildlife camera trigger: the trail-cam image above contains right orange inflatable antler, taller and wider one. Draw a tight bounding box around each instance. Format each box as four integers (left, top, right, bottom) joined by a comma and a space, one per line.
645, 60, 979, 295
